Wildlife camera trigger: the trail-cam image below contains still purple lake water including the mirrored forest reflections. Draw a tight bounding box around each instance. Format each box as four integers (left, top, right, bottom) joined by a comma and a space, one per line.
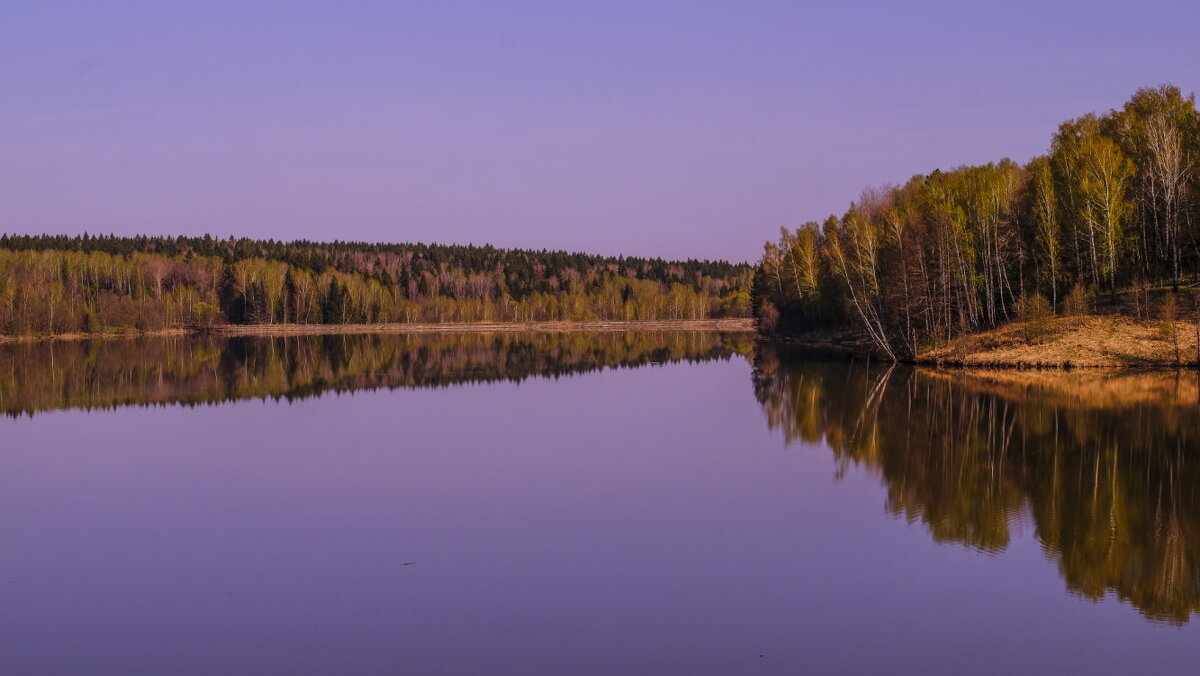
0, 334, 1200, 675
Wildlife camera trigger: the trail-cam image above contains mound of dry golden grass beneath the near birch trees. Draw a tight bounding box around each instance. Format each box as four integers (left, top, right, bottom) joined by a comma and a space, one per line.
917, 317, 1196, 369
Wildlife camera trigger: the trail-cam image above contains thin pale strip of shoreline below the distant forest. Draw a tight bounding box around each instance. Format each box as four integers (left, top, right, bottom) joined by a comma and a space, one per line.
0, 318, 755, 342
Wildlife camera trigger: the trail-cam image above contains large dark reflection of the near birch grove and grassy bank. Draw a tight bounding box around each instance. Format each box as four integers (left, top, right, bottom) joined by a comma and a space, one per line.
754, 346, 1200, 624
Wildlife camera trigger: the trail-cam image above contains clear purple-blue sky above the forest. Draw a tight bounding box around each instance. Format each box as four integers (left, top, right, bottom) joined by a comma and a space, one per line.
0, 0, 1200, 261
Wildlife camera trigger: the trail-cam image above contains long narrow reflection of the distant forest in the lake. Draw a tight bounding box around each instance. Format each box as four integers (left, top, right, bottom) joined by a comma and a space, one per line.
0, 331, 752, 415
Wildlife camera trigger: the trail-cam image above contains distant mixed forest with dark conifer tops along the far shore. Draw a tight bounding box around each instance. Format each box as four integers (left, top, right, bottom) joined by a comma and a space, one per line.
0, 234, 752, 335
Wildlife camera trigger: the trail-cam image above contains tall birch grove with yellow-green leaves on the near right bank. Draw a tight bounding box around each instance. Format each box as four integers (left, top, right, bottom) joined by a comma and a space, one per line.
751, 85, 1200, 358
